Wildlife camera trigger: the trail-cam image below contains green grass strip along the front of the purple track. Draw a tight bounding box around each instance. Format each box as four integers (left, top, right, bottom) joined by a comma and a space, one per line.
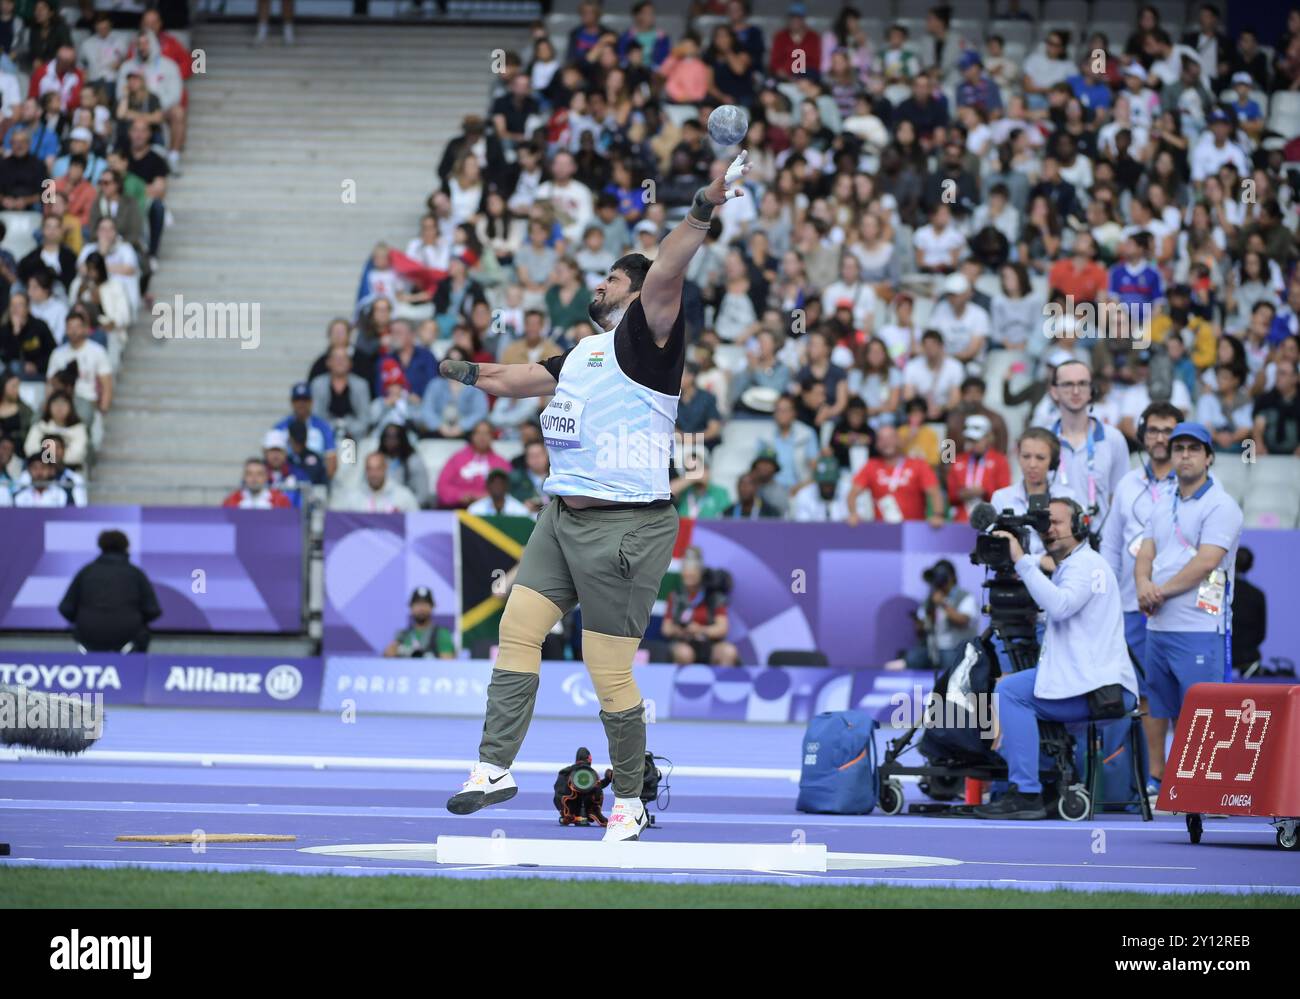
0, 861, 1300, 909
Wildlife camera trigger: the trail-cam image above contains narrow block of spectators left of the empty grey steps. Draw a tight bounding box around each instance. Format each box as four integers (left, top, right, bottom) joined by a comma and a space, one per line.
0, 0, 192, 507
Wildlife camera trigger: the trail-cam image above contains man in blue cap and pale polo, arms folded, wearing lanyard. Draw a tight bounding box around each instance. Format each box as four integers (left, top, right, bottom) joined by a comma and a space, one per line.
1134, 423, 1243, 778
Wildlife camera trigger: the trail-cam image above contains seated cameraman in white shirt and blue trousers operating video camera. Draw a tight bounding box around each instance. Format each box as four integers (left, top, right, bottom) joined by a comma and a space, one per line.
974, 498, 1138, 818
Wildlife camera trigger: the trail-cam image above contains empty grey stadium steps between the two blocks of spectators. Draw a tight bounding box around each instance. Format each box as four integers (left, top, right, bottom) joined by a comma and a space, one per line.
91, 25, 512, 505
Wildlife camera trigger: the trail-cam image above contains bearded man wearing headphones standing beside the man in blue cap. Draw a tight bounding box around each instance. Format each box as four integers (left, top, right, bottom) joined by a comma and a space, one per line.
1101, 402, 1183, 793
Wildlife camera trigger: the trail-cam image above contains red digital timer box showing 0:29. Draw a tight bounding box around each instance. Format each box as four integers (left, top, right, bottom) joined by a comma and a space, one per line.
1157, 683, 1300, 818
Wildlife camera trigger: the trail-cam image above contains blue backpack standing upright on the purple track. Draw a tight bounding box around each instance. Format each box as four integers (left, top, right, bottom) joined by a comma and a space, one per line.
796, 712, 880, 816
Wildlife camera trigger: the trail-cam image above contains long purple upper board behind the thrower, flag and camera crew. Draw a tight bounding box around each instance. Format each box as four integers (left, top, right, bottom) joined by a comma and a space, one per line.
314, 513, 1300, 670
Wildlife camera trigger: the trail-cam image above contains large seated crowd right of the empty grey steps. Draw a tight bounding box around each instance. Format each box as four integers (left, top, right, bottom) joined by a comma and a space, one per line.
218, 0, 1300, 527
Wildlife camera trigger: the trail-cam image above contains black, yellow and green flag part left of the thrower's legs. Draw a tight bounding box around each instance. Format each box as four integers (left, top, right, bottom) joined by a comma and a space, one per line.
456, 510, 533, 649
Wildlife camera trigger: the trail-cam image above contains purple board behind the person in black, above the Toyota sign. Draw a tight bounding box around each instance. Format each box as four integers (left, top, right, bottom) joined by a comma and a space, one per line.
0, 506, 303, 632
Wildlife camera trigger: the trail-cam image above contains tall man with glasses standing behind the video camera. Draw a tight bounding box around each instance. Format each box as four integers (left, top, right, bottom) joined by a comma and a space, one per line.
1048, 360, 1128, 532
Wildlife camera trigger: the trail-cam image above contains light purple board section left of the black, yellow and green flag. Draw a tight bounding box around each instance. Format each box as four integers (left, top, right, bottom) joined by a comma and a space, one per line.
322, 511, 460, 656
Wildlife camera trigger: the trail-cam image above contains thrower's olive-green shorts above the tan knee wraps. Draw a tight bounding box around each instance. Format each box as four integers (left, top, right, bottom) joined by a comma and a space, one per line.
515, 497, 677, 639
